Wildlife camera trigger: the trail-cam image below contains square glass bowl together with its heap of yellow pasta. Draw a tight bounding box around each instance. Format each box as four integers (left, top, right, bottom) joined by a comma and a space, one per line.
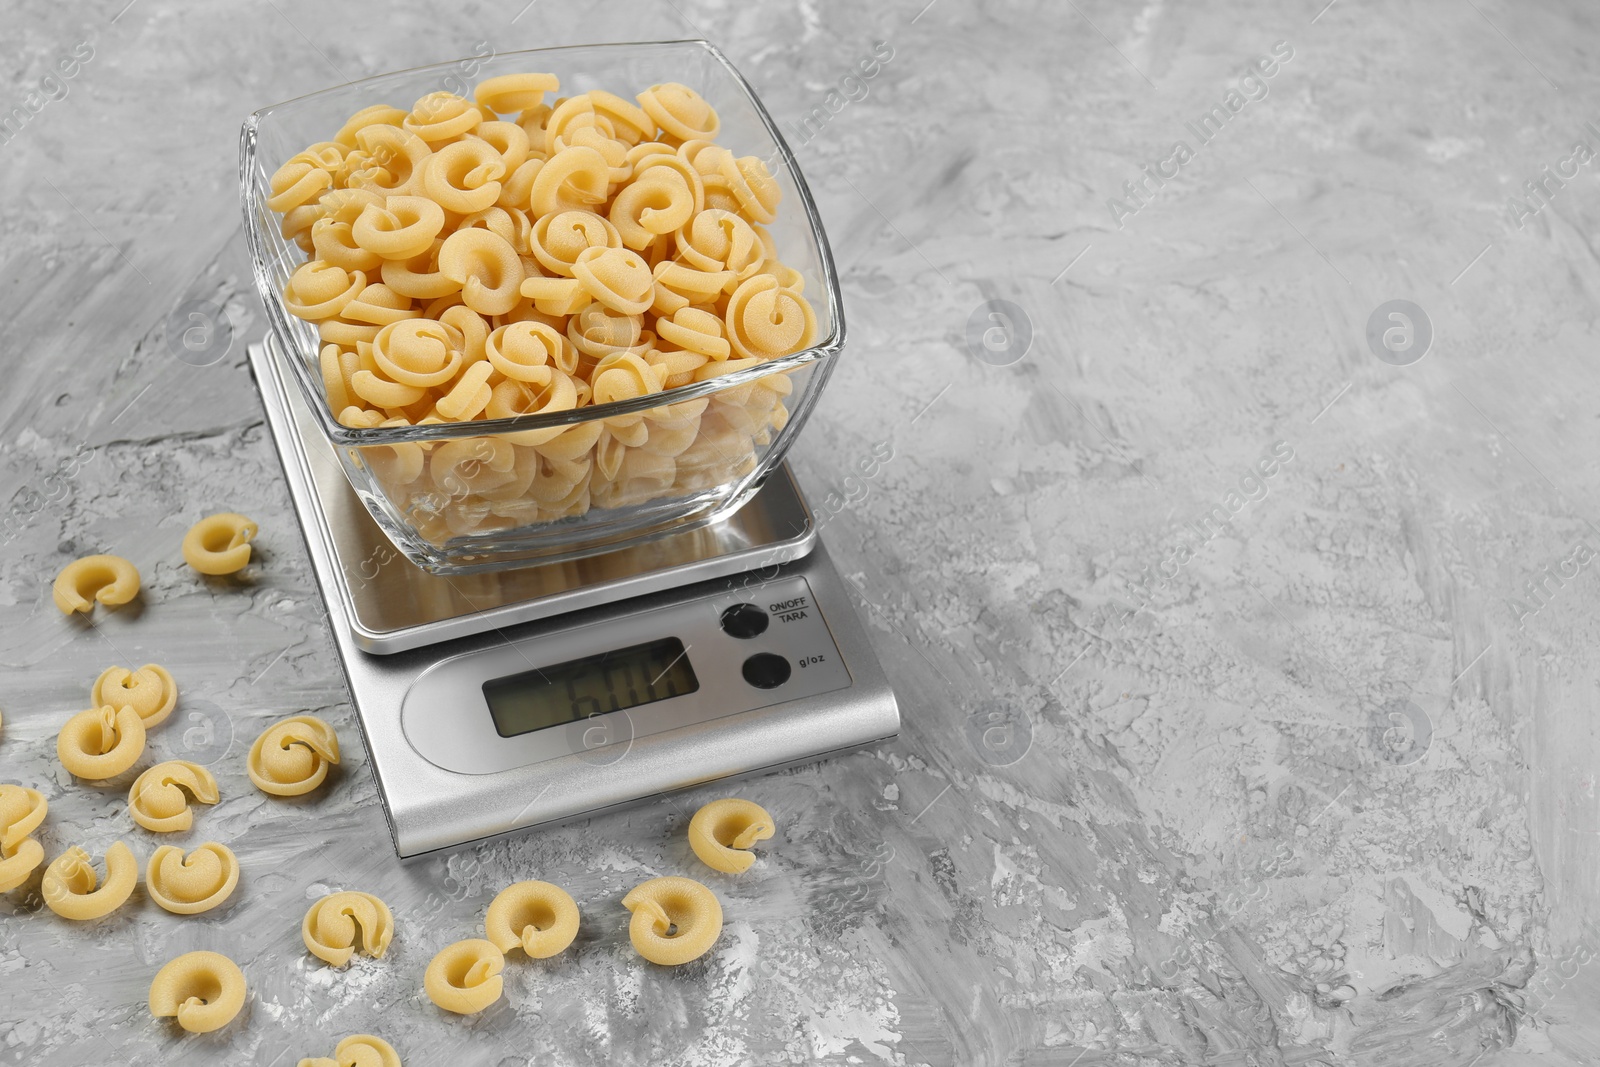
240, 42, 845, 573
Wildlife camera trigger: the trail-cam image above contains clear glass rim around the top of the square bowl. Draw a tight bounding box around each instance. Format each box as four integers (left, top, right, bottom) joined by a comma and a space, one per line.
238, 37, 845, 446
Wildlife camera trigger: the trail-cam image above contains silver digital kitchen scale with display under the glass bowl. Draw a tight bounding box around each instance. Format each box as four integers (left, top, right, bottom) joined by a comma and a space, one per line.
248, 334, 899, 857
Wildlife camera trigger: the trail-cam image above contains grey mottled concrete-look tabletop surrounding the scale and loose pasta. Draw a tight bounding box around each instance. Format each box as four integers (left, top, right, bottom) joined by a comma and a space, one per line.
0, 0, 1600, 1067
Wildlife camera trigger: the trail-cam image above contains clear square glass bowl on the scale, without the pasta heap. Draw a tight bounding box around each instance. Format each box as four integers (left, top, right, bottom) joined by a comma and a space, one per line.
240, 40, 845, 574
